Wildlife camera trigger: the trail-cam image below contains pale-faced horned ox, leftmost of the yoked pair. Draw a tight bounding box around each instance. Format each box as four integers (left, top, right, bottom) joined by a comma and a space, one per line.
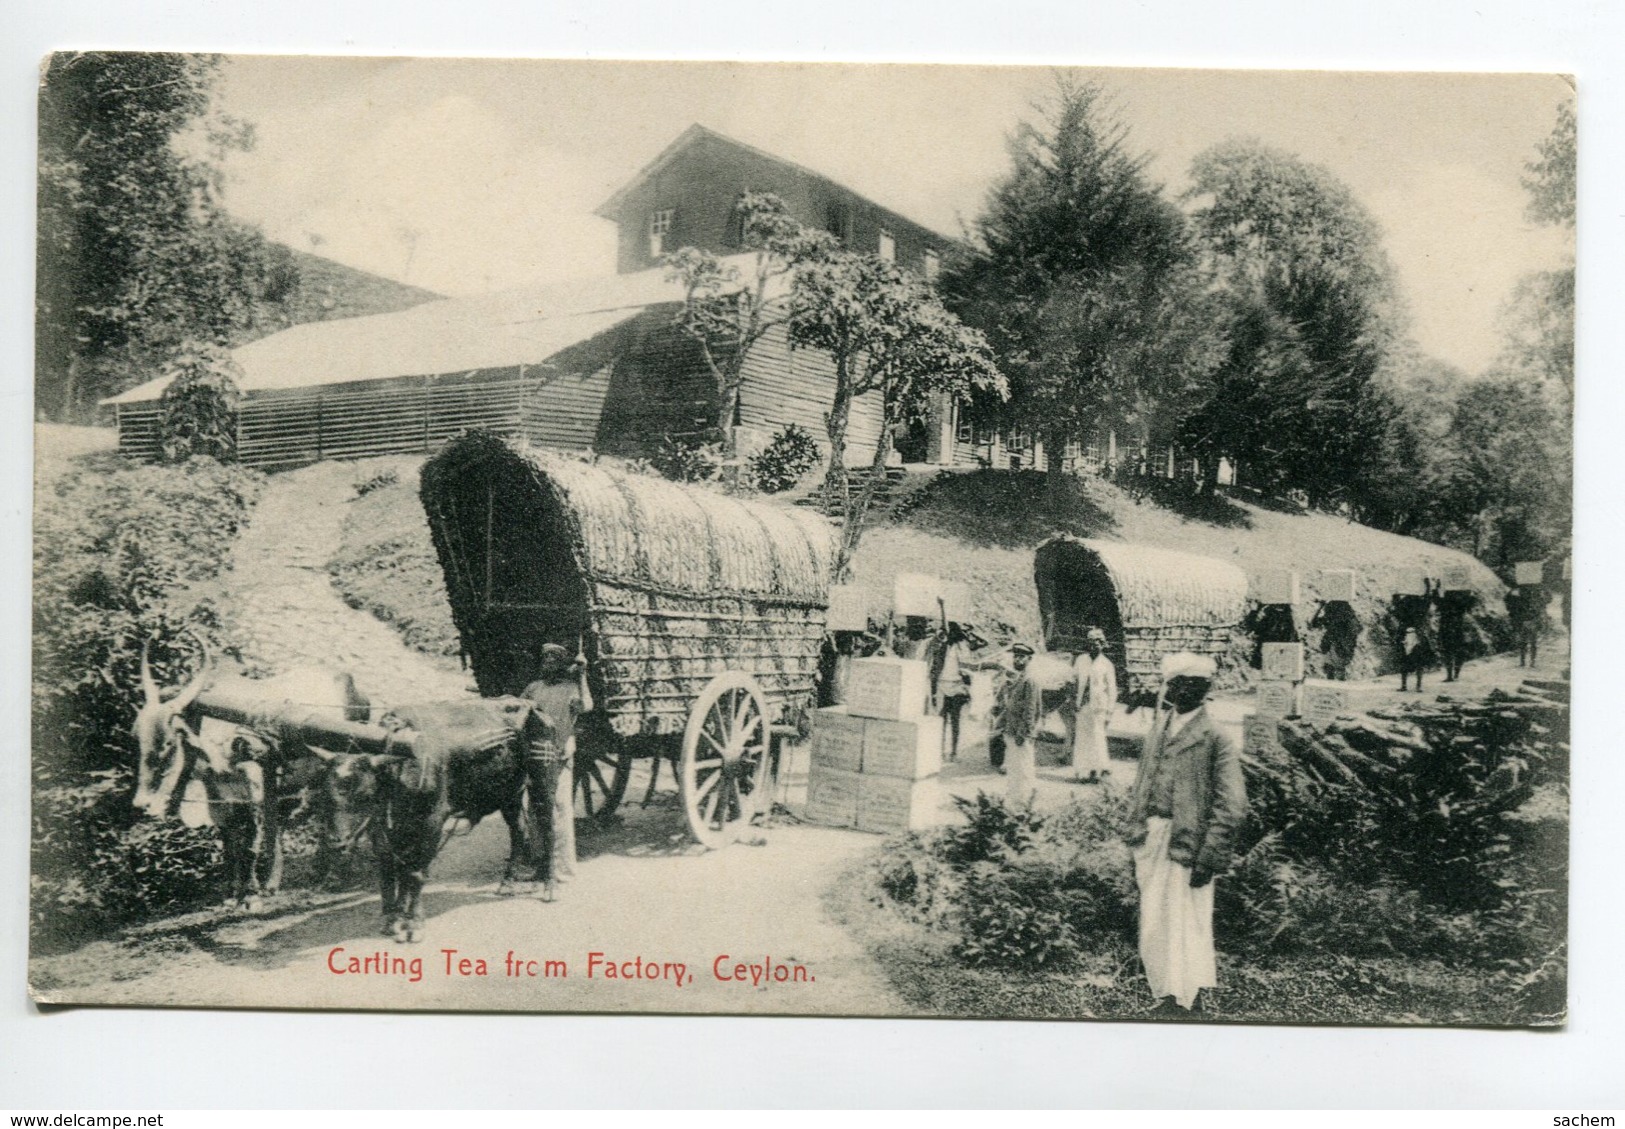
133, 648, 371, 910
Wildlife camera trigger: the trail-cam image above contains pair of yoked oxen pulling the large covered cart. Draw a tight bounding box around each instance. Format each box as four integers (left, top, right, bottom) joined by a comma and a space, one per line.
135, 651, 574, 942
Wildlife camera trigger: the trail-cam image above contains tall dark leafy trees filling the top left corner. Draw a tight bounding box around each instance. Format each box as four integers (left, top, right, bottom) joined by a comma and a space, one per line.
36, 52, 270, 419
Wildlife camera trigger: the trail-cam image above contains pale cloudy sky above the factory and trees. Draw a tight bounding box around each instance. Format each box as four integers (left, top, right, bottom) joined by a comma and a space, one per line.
219, 55, 1571, 374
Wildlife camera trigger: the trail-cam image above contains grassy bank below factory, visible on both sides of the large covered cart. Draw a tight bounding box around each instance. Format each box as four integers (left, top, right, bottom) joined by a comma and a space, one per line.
330, 456, 1502, 677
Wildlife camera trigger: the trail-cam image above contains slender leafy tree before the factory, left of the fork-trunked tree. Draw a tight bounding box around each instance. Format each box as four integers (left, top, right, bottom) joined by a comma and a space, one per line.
661, 192, 835, 468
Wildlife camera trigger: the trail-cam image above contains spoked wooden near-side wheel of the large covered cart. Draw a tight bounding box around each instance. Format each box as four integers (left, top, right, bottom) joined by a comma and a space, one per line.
678, 671, 772, 848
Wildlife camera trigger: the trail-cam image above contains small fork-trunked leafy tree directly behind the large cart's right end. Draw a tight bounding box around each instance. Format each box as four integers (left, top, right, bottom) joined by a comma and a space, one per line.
790, 252, 1006, 575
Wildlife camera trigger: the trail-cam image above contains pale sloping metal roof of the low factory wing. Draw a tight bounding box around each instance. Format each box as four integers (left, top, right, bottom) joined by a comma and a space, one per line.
102, 257, 767, 404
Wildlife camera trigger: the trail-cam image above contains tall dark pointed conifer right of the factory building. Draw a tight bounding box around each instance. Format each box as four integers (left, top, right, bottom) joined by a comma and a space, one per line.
941, 75, 1216, 506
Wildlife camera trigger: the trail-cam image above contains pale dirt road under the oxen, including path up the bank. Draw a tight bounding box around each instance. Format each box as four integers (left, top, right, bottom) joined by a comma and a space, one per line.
31, 463, 908, 1015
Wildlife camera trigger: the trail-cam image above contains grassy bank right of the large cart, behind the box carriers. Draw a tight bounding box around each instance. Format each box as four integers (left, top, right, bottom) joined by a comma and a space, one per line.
856, 471, 1503, 677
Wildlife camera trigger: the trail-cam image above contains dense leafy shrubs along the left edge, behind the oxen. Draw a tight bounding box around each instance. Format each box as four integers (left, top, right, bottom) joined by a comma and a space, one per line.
31, 456, 262, 944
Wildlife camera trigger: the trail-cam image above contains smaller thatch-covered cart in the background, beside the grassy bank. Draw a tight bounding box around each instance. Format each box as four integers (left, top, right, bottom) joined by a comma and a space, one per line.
1034, 534, 1246, 699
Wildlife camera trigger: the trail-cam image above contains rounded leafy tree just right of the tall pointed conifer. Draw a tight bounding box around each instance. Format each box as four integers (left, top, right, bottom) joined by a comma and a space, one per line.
1185, 141, 1404, 513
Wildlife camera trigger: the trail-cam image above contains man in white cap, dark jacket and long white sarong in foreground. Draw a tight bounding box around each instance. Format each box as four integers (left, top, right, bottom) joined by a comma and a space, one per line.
1126, 651, 1246, 1015
